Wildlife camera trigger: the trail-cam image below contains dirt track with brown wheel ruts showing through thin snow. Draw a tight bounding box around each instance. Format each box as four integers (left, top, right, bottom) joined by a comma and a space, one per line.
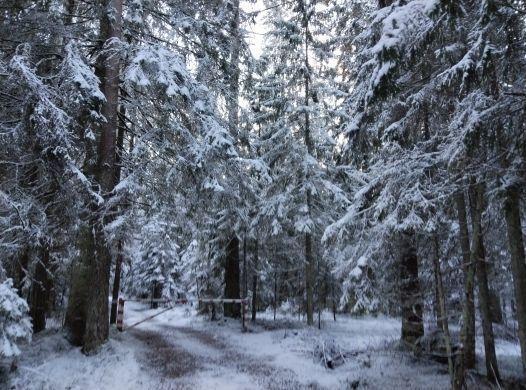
129, 324, 310, 389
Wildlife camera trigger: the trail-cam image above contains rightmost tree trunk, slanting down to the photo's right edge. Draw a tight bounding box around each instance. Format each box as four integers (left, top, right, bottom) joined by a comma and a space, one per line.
504, 187, 526, 375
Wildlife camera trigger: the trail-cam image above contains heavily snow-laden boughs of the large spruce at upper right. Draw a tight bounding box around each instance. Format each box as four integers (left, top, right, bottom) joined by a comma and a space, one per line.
324, 0, 521, 326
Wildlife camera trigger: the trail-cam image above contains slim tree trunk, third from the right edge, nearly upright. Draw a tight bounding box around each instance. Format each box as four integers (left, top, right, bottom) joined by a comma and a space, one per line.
455, 191, 476, 369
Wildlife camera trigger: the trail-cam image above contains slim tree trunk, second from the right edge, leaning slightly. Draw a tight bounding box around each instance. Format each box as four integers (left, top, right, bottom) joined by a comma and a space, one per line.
470, 184, 500, 382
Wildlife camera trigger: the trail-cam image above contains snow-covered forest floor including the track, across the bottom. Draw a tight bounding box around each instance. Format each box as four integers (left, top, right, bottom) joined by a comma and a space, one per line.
11, 302, 520, 390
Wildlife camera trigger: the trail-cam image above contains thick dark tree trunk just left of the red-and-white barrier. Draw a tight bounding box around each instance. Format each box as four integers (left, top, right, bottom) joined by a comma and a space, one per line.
65, 0, 123, 353
